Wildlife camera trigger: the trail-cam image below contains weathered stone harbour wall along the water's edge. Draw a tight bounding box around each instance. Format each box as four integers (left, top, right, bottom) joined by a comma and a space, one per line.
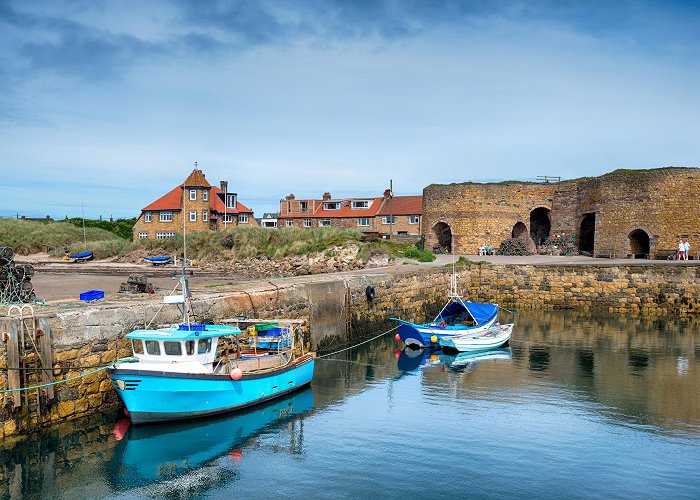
0, 263, 700, 439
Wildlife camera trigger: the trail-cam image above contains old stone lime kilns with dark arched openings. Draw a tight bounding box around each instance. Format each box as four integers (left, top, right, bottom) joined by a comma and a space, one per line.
422, 167, 700, 258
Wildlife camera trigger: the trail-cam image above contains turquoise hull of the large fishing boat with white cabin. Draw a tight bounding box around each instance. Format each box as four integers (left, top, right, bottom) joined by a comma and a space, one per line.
108, 354, 314, 424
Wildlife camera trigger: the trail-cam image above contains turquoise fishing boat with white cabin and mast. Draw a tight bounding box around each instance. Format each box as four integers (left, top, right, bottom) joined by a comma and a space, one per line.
107, 272, 315, 424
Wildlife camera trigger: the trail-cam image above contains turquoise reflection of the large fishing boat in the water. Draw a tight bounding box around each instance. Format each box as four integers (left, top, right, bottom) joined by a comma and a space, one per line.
109, 388, 314, 490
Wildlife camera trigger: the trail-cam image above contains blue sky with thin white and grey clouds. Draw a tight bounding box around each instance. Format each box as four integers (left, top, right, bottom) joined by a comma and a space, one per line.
0, 0, 700, 218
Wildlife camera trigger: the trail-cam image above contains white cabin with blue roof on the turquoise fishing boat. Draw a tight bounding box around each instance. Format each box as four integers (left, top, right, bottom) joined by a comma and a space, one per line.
126, 324, 241, 373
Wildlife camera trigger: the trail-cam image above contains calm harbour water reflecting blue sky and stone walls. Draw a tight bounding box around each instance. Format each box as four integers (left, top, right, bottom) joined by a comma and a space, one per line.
0, 311, 700, 499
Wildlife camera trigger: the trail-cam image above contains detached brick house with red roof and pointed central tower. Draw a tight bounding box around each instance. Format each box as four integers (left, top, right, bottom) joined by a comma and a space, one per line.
133, 169, 257, 239
